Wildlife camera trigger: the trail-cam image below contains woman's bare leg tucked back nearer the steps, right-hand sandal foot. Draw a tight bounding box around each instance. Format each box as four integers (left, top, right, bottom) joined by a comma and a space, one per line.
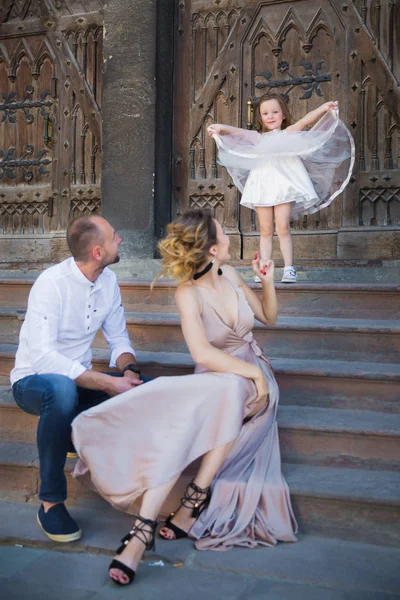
161, 441, 234, 540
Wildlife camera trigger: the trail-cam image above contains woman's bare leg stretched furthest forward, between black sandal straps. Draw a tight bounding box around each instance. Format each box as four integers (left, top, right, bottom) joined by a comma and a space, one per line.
110, 477, 178, 584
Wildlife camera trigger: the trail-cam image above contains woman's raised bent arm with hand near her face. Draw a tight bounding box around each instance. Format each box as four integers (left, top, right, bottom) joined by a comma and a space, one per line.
224, 262, 278, 325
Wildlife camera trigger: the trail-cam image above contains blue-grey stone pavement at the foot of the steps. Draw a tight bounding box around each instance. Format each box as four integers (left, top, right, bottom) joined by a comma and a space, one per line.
0, 502, 400, 600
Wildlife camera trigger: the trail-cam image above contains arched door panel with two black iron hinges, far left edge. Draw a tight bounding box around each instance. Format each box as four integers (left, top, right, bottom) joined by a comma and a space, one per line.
0, 35, 57, 233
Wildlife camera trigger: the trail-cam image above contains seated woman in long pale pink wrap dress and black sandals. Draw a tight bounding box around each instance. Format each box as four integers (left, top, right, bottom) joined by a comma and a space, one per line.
73, 210, 297, 585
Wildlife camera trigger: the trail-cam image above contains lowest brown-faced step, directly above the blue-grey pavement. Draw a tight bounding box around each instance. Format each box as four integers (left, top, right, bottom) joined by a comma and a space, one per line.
0, 442, 400, 547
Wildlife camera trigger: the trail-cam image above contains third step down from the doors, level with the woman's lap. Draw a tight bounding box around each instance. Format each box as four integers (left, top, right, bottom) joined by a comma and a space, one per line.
0, 344, 400, 414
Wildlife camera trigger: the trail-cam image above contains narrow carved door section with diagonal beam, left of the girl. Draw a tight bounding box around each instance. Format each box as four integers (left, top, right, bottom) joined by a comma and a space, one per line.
173, 3, 241, 257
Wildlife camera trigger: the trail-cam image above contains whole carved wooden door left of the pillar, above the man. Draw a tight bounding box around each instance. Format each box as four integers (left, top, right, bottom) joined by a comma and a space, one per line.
0, 0, 102, 235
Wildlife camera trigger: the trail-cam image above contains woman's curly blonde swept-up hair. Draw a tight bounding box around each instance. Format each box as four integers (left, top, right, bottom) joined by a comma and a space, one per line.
158, 209, 218, 282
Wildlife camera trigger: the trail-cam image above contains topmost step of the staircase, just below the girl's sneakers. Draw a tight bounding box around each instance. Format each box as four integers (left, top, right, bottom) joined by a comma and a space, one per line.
0, 277, 400, 320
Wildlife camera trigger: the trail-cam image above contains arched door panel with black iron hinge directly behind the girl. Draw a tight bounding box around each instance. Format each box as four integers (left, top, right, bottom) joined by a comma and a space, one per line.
241, 1, 347, 235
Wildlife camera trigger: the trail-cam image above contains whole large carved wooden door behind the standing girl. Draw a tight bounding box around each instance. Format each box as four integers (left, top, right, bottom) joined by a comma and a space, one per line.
173, 0, 400, 261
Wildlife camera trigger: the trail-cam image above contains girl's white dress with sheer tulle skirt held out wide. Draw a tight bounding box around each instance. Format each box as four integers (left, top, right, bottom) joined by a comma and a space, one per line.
213, 111, 354, 218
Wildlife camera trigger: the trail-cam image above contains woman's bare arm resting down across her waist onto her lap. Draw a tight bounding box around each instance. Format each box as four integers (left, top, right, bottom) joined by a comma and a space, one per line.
175, 284, 263, 380
